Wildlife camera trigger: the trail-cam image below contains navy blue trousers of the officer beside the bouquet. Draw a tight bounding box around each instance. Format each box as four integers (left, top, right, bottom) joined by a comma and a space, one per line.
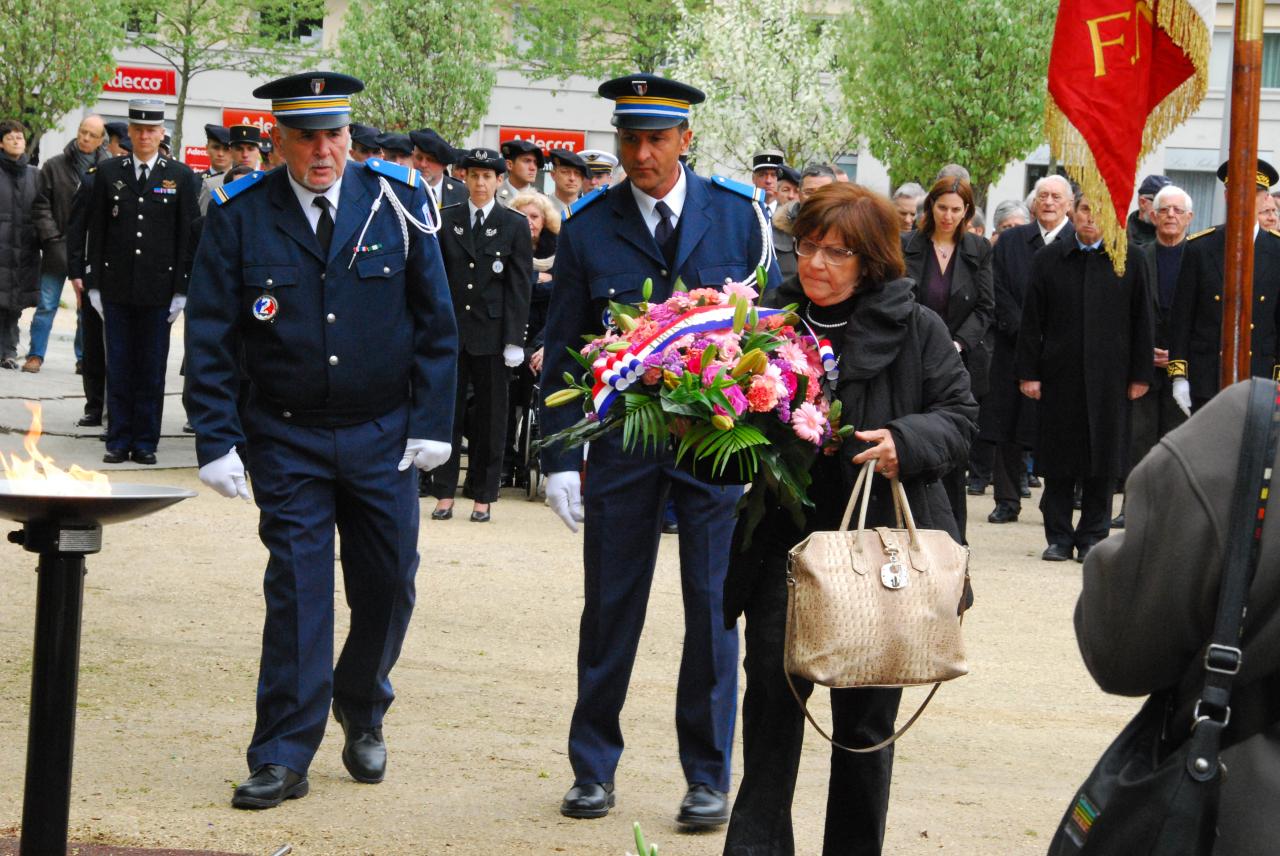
568, 432, 742, 791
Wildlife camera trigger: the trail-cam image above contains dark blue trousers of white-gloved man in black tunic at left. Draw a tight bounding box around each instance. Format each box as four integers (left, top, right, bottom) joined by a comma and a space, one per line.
102, 301, 169, 452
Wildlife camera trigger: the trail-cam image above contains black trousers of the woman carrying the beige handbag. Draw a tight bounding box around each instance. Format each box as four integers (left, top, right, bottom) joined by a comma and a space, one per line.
724, 557, 902, 856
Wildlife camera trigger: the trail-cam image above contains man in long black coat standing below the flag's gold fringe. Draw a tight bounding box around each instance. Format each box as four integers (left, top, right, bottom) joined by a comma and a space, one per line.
1001, 193, 1152, 562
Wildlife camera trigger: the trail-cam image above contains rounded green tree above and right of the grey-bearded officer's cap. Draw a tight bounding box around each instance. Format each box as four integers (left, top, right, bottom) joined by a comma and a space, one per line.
337, 0, 506, 143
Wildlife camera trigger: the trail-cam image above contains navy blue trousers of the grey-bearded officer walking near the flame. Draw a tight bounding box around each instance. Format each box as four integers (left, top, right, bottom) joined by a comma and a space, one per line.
243, 400, 419, 773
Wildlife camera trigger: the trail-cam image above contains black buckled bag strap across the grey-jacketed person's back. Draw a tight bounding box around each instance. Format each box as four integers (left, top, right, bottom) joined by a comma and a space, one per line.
1187, 379, 1280, 782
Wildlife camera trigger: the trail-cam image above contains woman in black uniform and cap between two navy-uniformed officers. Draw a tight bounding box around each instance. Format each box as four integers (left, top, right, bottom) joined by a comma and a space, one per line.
430, 148, 534, 523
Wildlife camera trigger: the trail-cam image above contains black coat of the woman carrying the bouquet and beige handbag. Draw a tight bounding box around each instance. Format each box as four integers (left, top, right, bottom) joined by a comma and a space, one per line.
724, 278, 978, 627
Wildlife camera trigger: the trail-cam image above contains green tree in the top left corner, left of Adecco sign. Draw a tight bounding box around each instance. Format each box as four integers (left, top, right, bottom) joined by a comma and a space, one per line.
0, 0, 124, 141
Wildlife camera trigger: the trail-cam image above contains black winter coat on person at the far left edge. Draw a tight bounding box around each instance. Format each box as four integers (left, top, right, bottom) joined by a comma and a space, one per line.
0, 155, 40, 312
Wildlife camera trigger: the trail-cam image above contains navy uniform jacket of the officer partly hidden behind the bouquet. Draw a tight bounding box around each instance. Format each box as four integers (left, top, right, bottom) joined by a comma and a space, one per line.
541, 166, 782, 472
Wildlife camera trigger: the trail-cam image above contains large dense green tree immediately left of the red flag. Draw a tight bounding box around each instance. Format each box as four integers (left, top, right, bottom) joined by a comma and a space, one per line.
841, 0, 1057, 200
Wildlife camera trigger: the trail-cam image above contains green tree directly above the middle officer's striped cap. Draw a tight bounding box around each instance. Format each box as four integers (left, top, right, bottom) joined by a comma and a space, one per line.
507, 0, 708, 81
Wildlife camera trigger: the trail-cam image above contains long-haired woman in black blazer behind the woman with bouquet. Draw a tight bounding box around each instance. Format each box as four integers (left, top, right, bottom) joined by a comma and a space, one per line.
902, 178, 996, 540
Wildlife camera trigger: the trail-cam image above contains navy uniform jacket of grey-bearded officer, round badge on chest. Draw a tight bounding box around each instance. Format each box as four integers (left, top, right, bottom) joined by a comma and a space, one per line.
187, 162, 458, 466
